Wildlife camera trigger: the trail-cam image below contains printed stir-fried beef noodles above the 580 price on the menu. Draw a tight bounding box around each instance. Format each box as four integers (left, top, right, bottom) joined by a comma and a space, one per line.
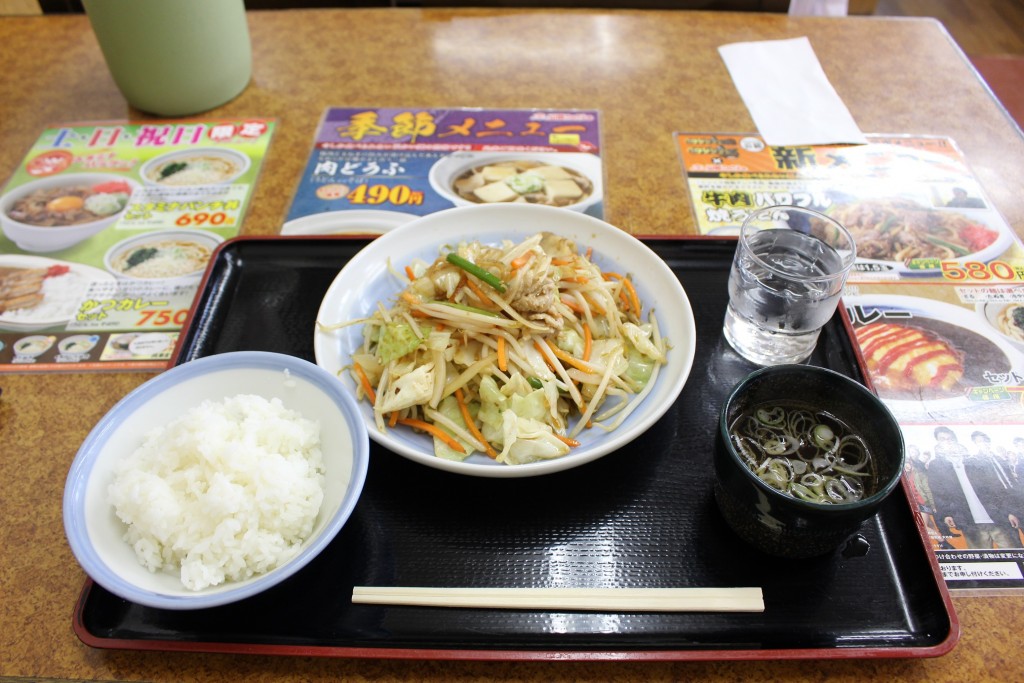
815, 199, 999, 262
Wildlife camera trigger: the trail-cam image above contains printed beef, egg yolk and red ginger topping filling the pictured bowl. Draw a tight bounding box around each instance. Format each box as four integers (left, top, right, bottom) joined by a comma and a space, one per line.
7, 180, 131, 227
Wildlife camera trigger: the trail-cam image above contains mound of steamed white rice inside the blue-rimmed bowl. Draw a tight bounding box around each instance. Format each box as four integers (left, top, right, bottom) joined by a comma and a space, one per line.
109, 394, 324, 591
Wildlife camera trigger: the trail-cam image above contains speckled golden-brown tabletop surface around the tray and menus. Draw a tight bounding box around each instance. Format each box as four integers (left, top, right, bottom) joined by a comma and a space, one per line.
0, 9, 1024, 682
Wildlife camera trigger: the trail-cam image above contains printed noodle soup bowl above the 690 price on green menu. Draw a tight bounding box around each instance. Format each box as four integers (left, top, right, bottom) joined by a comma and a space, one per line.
139, 147, 252, 187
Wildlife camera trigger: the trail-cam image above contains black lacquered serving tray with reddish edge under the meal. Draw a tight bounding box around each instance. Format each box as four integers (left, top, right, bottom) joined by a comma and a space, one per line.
75, 238, 959, 659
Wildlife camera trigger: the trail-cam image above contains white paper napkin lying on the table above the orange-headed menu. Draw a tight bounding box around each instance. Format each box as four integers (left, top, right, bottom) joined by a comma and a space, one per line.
718, 38, 867, 145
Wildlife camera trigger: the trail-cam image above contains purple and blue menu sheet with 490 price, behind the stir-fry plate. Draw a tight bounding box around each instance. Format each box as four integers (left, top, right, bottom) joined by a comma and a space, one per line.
282, 108, 603, 234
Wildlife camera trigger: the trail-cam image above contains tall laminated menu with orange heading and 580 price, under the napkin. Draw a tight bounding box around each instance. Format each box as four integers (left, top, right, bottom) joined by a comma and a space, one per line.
676, 133, 1024, 592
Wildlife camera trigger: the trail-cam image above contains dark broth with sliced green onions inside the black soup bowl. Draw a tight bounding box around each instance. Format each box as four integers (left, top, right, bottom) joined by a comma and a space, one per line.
729, 403, 877, 504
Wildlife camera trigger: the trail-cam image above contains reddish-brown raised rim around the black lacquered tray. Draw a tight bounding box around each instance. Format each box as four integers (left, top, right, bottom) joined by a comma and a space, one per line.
73, 234, 961, 661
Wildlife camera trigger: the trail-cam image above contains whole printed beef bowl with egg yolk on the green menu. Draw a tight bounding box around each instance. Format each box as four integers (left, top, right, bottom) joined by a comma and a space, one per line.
0, 173, 139, 253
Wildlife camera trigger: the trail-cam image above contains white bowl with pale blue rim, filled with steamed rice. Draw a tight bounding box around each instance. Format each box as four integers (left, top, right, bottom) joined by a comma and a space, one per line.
63, 351, 370, 609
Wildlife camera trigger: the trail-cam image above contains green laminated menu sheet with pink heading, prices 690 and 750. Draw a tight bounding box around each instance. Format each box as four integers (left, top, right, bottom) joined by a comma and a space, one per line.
0, 119, 274, 373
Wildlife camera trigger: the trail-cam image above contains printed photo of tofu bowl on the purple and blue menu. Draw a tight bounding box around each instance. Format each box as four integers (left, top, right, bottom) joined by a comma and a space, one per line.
428, 152, 603, 212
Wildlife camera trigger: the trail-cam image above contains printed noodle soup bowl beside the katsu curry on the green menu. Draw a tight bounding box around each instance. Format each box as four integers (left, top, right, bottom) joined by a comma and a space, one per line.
103, 230, 223, 282
